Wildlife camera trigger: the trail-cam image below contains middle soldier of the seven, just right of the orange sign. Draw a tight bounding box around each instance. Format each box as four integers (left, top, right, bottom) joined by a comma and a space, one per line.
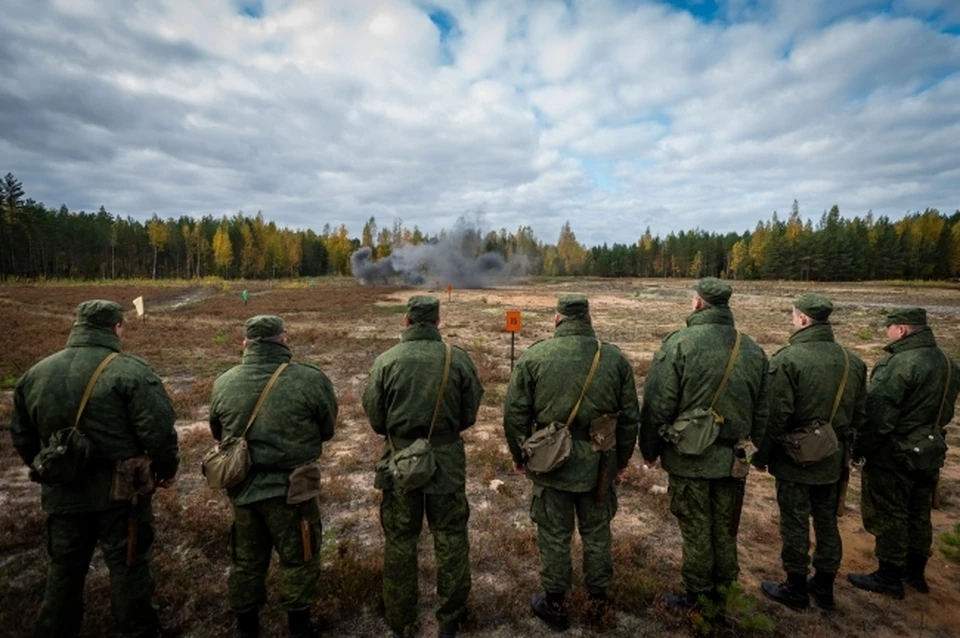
503, 295, 640, 630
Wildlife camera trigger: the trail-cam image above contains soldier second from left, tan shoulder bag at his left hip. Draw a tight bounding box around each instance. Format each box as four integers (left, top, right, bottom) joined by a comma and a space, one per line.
210, 315, 337, 638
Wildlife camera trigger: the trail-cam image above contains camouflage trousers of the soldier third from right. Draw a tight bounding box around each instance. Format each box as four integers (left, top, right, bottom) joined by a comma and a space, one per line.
670, 474, 740, 594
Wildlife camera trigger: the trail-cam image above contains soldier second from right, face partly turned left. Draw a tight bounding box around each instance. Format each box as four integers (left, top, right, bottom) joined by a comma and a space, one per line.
753, 293, 867, 610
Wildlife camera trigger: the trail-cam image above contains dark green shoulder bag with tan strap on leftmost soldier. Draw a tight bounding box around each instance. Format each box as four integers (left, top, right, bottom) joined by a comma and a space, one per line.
30, 352, 120, 487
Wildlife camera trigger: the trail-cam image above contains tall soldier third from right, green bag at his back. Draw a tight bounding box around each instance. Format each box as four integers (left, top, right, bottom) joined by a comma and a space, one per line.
640, 277, 768, 609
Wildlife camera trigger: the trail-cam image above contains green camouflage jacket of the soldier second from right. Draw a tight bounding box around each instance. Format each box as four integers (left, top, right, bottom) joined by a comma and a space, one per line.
753, 324, 867, 485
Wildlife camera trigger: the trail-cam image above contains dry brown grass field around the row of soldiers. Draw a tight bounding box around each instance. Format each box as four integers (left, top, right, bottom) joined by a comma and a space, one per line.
0, 279, 960, 637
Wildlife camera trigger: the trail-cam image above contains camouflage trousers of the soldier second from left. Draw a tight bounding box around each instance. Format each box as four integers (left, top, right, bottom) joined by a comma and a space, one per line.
227, 496, 321, 613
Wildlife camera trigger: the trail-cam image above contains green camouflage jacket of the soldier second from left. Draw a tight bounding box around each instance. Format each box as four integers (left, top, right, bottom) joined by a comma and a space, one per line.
210, 342, 337, 505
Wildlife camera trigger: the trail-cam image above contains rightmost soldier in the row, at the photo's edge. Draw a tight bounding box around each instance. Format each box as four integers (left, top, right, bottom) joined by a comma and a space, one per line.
847, 308, 960, 598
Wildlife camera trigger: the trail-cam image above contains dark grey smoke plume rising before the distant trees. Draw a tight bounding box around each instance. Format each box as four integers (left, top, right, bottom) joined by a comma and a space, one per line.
350, 221, 528, 288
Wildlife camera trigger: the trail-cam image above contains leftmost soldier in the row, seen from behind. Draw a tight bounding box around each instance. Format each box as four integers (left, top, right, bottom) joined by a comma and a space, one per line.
10, 300, 180, 637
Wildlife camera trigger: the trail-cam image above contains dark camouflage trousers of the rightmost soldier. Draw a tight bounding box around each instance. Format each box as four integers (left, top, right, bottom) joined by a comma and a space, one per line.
860, 461, 940, 567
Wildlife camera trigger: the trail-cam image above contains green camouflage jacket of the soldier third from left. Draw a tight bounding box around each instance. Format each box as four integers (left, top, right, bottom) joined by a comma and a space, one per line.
363, 323, 483, 494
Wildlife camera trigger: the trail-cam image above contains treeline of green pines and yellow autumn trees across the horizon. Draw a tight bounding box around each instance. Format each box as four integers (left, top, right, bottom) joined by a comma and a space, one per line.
0, 173, 960, 281
